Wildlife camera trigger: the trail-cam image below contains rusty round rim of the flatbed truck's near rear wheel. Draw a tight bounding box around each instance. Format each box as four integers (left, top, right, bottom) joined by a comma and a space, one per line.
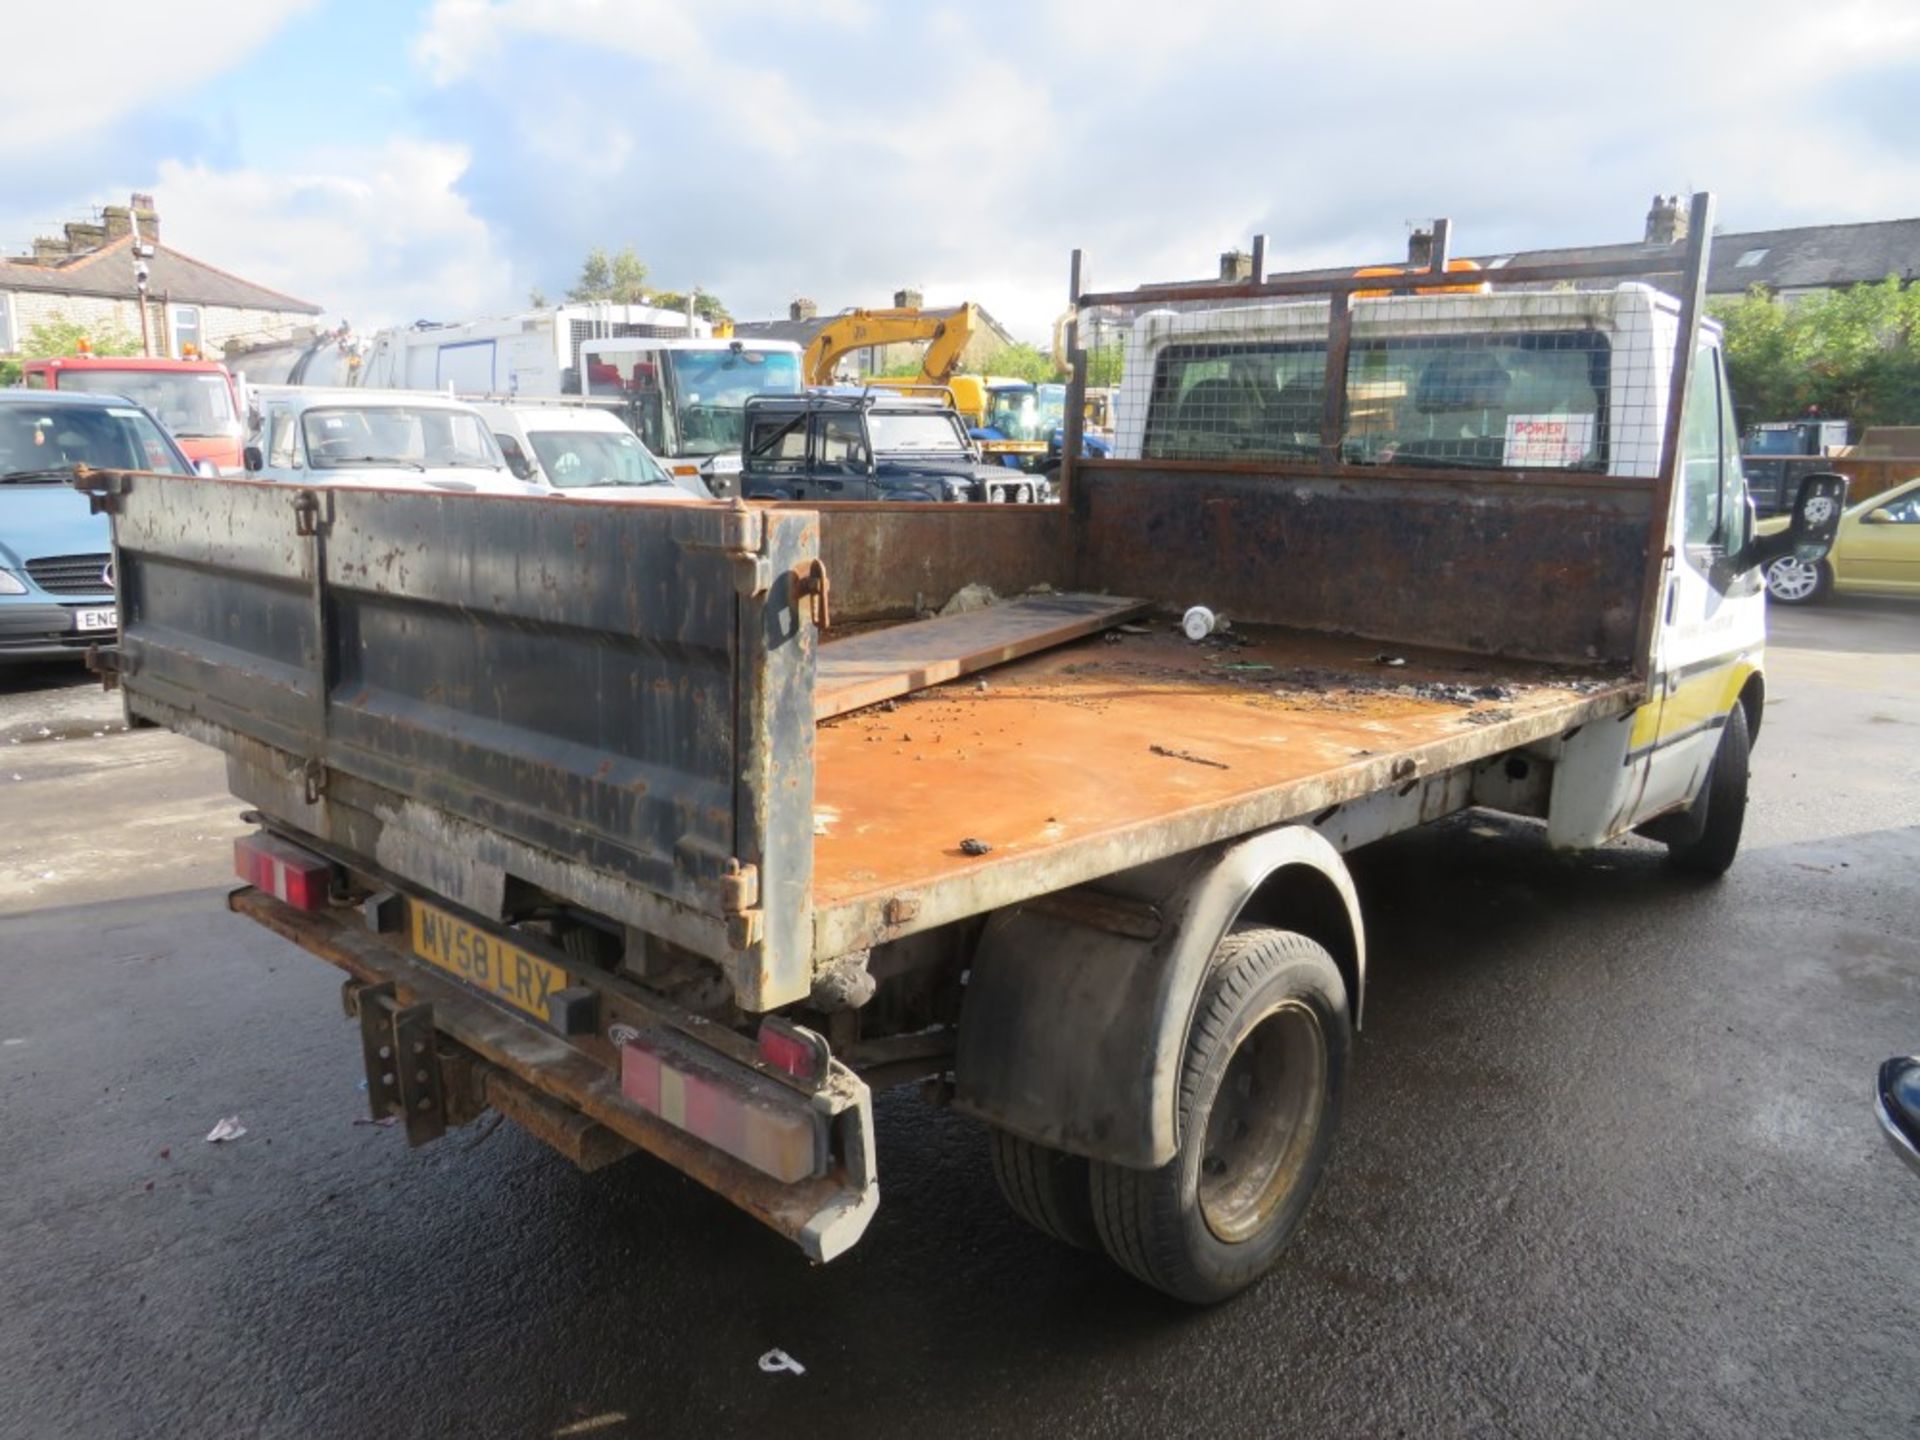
1200, 1000, 1327, 1244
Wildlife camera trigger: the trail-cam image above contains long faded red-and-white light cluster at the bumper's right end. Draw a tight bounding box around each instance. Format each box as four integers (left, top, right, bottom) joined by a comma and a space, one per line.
620, 1027, 828, 1185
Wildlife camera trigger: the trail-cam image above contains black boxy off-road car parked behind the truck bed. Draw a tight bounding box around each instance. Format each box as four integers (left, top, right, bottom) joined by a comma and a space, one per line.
739, 390, 1048, 501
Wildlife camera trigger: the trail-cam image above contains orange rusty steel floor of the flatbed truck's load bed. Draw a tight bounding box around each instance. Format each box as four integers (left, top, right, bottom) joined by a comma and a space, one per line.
814, 616, 1642, 954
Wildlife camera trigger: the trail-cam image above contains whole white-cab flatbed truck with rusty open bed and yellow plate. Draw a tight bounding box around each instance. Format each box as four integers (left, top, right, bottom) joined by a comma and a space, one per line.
81, 200, 1812, 1302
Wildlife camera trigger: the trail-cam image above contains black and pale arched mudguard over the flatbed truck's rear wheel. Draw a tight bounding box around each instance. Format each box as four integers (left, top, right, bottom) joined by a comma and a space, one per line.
954, 826, 1367, 1169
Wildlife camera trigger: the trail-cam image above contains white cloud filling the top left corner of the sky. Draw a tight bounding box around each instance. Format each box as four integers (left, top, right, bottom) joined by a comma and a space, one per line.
0, 0, 317, 160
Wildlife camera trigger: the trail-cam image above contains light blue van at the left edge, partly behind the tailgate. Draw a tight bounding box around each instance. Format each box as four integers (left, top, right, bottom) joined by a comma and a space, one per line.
0, 390, 194, 664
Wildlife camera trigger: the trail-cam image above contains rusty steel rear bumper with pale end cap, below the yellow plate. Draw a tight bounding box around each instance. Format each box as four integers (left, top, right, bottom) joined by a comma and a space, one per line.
228, 887, 879, 1261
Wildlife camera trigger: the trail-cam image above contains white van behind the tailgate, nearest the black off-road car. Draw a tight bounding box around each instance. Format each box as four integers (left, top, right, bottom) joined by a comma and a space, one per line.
474, 401, 712, 501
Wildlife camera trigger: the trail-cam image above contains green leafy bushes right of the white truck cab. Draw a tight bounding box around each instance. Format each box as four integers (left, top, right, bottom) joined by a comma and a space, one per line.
1711, 276, 1920, 432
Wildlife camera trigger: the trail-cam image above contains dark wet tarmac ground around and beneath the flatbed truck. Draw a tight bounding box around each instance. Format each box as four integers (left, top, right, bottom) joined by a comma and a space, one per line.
0, 601, 1920, 1440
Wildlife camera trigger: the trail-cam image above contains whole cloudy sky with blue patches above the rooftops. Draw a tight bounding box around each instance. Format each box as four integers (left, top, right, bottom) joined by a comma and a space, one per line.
0, 0, 1920, 340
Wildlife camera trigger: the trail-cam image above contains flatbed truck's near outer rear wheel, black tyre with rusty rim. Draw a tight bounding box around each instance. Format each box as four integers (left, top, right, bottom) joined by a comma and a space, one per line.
1089, 927, 1352, 1306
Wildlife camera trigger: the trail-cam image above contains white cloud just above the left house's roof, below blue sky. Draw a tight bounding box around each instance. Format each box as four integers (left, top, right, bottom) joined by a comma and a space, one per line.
154, 140, 515, 330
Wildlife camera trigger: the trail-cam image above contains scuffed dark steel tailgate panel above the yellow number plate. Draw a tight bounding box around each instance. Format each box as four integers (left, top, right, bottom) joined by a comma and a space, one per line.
96, 474, 818, 1008
